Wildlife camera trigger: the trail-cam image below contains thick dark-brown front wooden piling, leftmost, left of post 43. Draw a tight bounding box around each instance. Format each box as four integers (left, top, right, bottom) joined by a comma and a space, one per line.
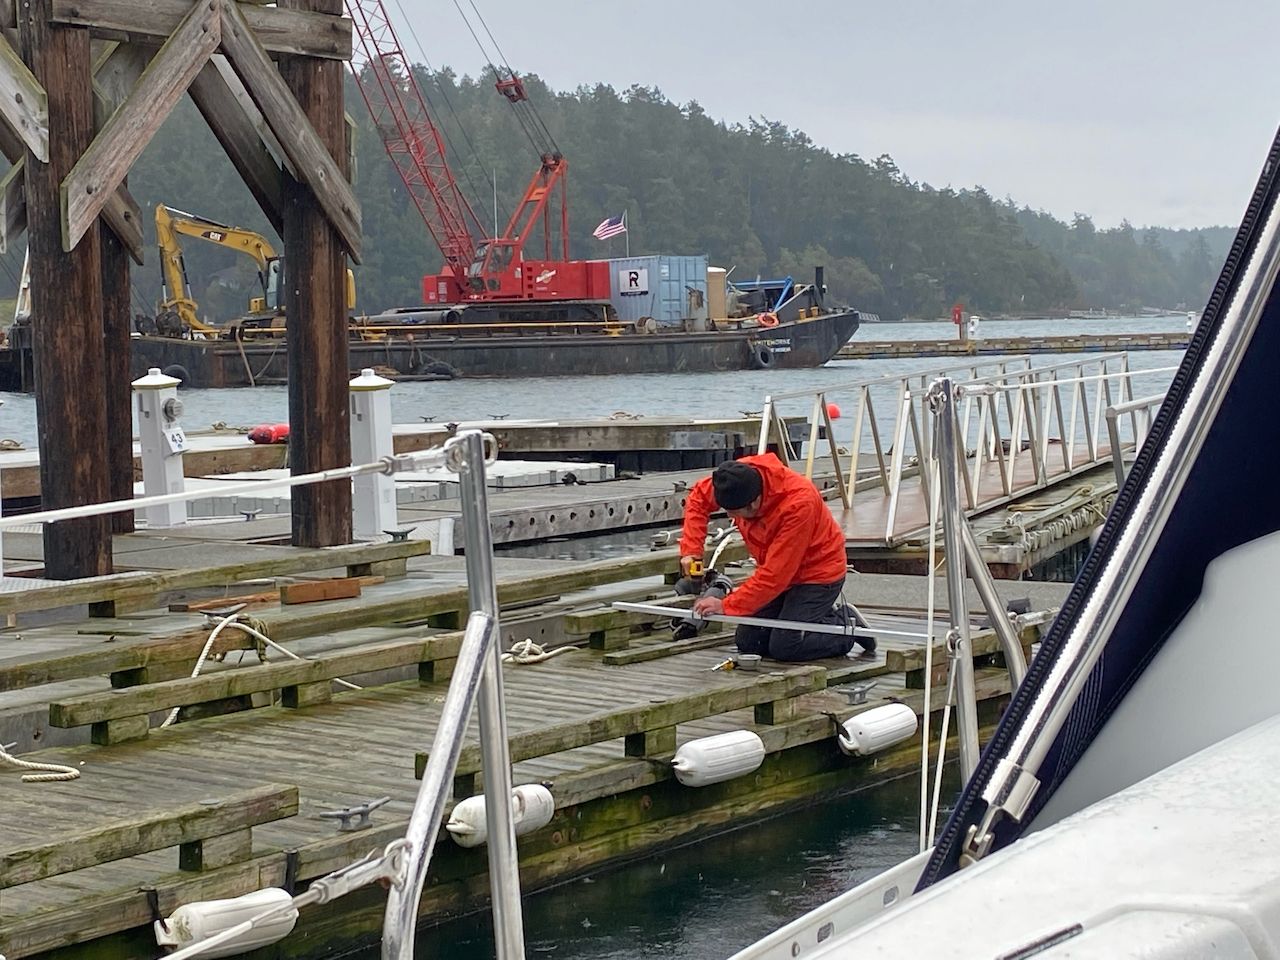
18, 0, 111, 580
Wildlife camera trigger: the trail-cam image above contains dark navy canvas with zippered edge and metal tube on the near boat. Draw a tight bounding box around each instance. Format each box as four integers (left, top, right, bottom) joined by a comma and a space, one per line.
919, 124, 1280, 888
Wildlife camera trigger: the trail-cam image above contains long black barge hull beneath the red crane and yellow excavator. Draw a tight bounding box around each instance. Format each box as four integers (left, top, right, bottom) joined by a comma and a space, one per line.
120, 310, 858, 387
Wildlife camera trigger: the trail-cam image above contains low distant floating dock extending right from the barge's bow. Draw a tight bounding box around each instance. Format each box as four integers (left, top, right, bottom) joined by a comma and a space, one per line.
836, 333, 1192, 360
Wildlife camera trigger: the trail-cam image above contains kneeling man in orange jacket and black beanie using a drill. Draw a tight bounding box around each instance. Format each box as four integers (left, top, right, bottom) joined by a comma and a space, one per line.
680, 453, 876, 660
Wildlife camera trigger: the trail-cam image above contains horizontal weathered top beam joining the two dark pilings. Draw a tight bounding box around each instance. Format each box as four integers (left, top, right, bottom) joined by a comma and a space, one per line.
46, 0, 352, 60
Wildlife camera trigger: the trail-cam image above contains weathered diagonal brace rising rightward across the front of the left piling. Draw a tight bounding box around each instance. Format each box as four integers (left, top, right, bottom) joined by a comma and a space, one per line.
61, 0, 221, 251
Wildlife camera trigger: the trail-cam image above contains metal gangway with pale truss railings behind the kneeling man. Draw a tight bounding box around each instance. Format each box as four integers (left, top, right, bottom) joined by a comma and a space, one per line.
759, 352, 1175, 545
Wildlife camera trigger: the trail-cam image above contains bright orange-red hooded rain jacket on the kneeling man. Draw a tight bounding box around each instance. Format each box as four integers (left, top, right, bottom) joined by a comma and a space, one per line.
680, 453, 849, 617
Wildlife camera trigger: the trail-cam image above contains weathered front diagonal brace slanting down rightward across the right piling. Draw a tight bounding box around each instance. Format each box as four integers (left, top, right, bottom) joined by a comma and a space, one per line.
216, 0, 361, 264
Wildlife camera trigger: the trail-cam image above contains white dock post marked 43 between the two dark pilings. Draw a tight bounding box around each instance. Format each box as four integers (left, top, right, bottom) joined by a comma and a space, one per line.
133, 367, 187, 529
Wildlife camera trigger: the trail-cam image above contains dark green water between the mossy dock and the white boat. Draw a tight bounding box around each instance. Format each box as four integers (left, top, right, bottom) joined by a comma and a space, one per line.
355, 773, 959, 960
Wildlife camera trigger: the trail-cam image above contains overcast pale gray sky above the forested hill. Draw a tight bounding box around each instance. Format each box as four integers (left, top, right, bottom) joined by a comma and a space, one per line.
385, 0, 1280, 227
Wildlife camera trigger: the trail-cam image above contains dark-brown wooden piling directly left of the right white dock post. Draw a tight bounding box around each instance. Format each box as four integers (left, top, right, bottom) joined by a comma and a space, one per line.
280, 0, 352, 547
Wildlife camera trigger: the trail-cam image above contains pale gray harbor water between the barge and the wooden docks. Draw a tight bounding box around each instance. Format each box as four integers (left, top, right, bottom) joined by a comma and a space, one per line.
0, 316, 1187, 447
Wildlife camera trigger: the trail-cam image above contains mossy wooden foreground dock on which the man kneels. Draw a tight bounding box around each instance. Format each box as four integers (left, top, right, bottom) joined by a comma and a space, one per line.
0, 535, 1062, 960
